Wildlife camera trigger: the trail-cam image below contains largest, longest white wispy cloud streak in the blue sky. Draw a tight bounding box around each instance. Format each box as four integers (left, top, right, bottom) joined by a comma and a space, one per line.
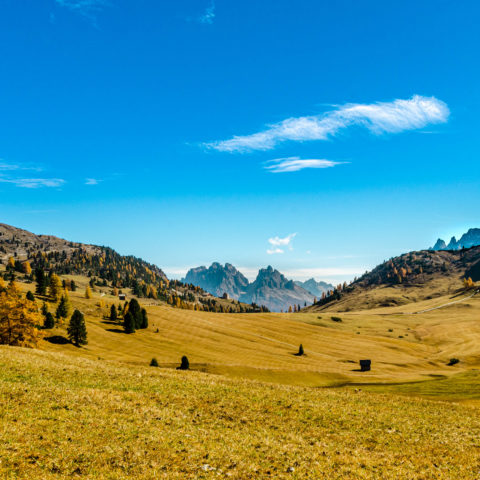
204, 95, 450, 152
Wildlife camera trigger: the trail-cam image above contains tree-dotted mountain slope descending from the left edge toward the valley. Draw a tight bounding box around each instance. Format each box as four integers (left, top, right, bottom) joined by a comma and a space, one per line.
0, 224, 265, 313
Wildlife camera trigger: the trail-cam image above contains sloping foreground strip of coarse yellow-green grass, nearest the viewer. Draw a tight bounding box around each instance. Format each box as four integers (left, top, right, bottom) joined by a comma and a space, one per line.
0, 347, 480, 480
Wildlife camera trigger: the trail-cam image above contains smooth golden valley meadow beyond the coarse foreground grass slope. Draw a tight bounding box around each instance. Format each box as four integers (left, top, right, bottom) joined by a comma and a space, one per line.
31, 278, 480, 386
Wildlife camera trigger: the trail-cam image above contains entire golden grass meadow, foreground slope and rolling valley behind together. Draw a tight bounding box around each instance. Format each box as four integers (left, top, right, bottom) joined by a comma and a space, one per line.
0, 277, 480, 480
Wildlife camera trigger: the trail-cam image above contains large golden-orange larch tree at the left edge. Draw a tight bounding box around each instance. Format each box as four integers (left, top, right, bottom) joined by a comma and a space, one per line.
0, 282, 42, 348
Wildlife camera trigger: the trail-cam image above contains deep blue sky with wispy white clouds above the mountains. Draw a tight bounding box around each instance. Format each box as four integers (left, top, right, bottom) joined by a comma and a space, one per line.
0, 0, 480, 281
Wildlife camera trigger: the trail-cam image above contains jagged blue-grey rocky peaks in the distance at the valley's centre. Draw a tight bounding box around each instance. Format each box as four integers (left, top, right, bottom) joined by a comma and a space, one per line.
182, 262, 326, 311
